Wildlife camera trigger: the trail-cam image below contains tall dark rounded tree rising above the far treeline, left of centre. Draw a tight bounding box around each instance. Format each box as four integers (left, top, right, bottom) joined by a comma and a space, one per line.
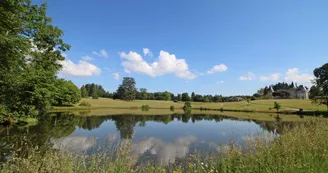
117, 77, 137, 101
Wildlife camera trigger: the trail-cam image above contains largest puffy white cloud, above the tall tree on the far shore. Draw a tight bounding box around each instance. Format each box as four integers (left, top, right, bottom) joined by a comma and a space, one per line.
120, 50, 197, 79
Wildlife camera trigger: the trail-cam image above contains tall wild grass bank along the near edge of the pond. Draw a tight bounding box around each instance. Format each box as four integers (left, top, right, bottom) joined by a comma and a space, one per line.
0, 119, 328, 173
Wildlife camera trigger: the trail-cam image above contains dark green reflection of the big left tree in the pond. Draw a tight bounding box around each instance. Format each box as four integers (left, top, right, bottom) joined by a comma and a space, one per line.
0, 114, 79, 162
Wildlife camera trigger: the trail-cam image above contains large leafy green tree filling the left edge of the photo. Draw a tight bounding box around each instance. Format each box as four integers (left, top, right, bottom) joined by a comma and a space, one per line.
0, 0, 70, 115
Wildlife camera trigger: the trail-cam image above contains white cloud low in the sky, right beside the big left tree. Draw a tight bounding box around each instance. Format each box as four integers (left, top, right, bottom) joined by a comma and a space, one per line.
59, 59, 101, 76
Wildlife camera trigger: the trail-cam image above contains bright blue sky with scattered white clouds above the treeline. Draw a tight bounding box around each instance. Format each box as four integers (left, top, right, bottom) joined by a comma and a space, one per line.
37, 0, 328, 95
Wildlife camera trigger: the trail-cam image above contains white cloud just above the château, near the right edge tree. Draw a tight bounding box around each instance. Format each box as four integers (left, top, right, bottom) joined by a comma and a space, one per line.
284, 68, 314, 85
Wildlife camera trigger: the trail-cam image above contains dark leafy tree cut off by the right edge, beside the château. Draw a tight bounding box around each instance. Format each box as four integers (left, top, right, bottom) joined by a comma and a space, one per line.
310, 63, 328, 111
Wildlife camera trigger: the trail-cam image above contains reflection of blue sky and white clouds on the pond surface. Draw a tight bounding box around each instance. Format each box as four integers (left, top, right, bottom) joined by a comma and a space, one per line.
62, 119, 267, 165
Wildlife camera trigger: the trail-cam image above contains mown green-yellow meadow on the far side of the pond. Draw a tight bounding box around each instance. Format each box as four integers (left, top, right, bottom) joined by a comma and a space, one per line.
54, 98, 327, 112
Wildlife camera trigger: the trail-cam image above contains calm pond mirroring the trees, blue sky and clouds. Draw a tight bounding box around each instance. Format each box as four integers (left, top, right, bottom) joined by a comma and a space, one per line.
0, 111, 294, 165
